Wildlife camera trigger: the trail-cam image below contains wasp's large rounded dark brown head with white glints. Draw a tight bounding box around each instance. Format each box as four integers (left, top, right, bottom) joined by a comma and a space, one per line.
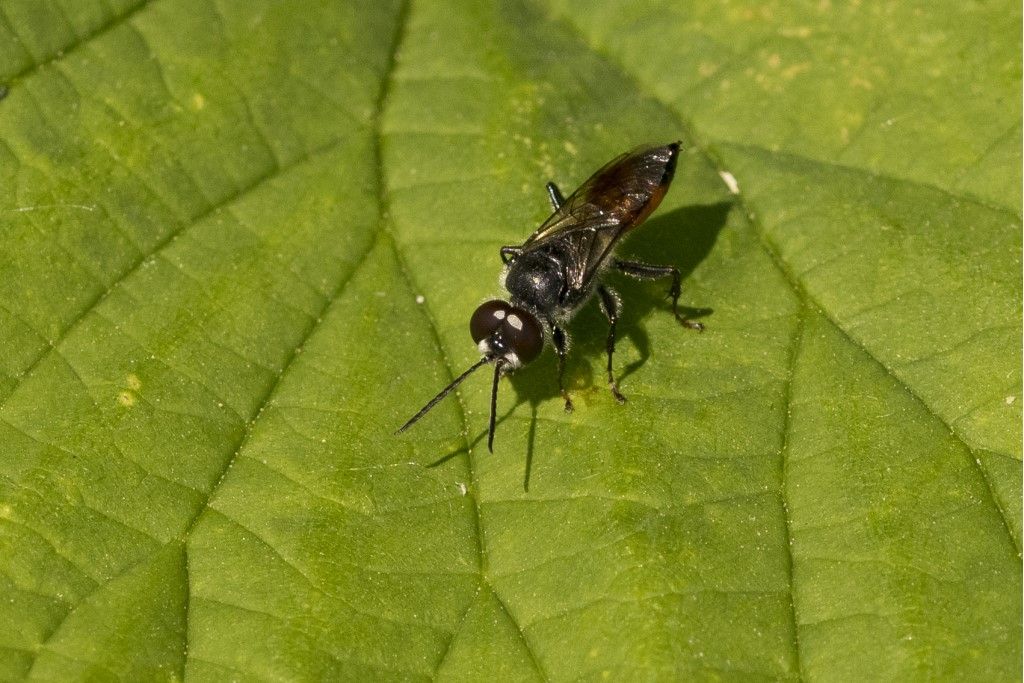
469, 299, 544, 366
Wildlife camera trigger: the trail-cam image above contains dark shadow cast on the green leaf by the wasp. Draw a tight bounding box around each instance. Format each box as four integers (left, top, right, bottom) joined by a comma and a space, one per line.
483, 202, 734, 490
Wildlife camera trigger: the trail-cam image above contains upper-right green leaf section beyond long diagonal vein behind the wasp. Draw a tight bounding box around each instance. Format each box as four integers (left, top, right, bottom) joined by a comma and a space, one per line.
540, 2, 1022, 551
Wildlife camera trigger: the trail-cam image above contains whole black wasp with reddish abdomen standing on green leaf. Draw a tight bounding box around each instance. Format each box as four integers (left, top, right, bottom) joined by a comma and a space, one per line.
398, 142, 703, 451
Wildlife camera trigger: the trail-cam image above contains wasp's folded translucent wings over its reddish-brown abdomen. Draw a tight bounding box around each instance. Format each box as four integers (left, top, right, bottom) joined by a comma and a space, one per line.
522, 142, 679, 290
